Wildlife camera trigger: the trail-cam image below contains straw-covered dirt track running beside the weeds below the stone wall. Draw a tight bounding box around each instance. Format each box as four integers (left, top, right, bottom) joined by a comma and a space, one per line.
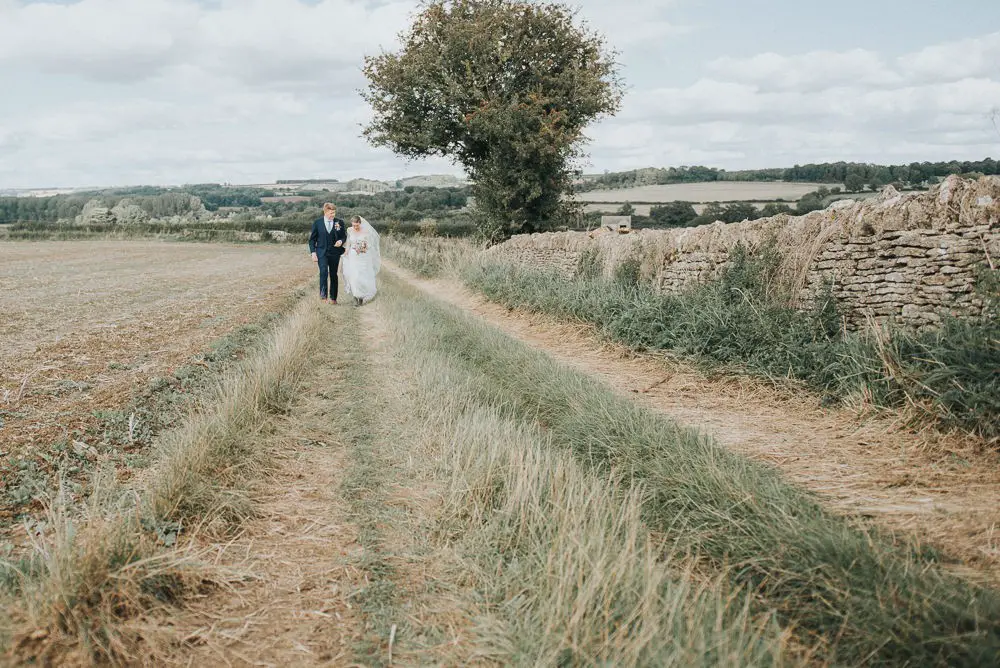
387, 263, 1000, 582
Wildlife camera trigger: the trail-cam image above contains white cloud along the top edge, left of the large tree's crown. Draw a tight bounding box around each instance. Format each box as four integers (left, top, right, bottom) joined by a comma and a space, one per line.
0, 0, 413, 85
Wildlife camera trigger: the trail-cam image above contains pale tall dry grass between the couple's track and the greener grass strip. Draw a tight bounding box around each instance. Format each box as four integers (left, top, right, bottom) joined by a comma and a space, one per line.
380, 284, 801, 667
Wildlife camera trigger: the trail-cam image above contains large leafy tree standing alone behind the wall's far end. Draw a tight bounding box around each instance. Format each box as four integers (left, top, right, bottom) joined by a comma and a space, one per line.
364, 0, 623, 241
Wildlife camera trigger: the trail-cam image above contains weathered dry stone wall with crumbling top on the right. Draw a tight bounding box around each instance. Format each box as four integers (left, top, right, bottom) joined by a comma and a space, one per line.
486, 176, 1000, 329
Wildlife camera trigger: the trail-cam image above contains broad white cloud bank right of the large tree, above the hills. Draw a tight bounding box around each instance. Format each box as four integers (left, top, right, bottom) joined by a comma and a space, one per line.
595, 33, 1000, 168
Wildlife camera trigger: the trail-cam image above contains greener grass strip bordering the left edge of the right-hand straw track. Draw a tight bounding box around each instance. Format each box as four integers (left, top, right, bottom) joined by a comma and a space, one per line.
376, 272, 1000, 666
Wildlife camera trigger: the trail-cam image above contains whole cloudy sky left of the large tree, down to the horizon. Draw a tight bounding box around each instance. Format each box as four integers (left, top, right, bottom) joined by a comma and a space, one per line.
0, 0, 426, 185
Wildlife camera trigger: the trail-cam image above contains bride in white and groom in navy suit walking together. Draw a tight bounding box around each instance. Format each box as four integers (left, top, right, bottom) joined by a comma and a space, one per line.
309, 202, 382, 306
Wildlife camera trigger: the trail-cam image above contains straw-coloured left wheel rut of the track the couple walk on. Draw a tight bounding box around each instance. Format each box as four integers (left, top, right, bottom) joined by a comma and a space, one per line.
156, 324, 365, 666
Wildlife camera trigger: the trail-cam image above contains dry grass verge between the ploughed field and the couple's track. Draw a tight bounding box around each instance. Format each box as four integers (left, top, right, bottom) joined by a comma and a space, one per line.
0, 302, 322, 663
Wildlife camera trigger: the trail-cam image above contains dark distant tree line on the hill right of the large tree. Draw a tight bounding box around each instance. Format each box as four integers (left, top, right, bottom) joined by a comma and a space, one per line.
575, 158, 1000, 192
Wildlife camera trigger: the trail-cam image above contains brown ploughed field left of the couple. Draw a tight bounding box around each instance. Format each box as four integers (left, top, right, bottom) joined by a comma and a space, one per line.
0, 241, 313, 525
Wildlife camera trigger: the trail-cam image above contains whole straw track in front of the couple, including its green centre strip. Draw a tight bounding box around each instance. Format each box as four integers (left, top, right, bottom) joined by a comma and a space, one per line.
158, 305, 482, 666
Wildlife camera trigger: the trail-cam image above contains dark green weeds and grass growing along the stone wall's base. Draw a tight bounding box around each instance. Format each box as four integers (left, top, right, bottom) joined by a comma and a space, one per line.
464, 249, 1000, 443
